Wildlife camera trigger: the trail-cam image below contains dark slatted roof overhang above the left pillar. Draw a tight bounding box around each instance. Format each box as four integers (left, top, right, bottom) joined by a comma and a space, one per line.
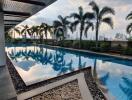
0, 0, 56, 29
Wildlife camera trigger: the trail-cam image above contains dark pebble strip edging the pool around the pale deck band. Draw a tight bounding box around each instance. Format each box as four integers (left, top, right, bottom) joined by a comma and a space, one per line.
7, 57, 106, 100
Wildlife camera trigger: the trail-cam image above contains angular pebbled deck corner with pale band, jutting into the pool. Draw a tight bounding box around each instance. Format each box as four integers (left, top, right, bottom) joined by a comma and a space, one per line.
7, 57, 106, 100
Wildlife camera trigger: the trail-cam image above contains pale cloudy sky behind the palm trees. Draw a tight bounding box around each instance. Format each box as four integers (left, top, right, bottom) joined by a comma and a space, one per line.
18, 0, 132, 40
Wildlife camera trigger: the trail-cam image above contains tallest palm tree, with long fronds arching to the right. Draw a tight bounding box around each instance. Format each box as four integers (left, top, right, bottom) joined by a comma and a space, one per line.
89, 1, 115, 48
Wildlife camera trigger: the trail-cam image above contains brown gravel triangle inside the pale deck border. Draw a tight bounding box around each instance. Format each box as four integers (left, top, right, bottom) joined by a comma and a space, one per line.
28, 80, 83, 100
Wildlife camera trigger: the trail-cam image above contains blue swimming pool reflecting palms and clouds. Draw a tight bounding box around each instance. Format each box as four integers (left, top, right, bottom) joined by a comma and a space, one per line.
6, 44, 132, 100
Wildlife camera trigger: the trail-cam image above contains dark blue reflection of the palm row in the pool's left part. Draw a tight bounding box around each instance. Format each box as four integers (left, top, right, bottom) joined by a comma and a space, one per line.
9, 47, 74, 75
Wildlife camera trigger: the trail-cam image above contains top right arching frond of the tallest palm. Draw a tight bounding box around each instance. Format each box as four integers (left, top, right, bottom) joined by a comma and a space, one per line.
99, 7, 115, 18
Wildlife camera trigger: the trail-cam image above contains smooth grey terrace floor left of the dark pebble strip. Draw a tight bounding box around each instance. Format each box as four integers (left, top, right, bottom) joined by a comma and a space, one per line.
0, 66, 16, 100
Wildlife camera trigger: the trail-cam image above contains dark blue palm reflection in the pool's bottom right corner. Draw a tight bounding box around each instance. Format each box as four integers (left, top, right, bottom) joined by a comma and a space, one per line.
119, 77, 132, 100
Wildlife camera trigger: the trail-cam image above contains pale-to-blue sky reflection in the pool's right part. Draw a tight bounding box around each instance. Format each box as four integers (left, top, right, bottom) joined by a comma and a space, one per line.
97, 61, 132, 100
